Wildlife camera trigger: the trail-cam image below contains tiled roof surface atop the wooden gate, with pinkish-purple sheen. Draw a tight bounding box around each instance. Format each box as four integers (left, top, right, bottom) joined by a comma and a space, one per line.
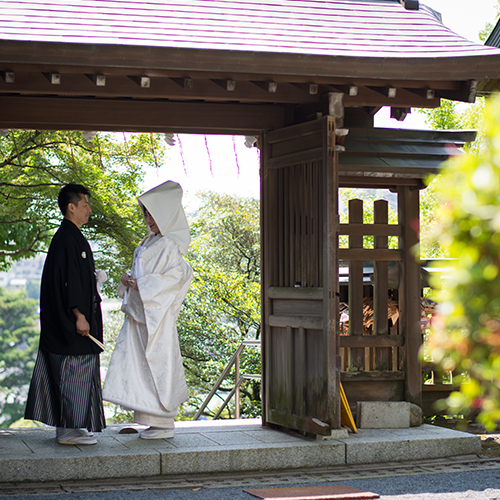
0, 0, 500, 58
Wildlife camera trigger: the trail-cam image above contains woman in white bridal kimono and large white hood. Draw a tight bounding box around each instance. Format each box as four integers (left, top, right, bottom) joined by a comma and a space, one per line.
103, 181, 193, 439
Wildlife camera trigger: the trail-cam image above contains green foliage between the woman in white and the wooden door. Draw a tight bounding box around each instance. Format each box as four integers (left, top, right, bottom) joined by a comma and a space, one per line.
177, 193, 261, 417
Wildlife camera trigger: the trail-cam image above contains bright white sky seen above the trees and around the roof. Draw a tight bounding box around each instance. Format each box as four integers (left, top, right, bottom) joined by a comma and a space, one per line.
144, 0, 499, 207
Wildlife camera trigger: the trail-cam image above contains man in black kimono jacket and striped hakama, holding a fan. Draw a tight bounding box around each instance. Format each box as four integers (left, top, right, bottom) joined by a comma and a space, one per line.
25, 184, 106, 445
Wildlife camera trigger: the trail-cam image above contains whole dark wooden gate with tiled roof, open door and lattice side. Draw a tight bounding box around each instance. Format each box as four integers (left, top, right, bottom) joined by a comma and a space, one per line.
0, 0, 500, 434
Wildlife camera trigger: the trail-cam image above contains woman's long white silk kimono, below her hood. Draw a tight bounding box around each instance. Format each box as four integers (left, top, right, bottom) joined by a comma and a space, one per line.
103, 234, 193, 425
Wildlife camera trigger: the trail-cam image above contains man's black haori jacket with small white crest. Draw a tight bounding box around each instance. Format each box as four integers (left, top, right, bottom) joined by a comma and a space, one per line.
40, 219, 102, 355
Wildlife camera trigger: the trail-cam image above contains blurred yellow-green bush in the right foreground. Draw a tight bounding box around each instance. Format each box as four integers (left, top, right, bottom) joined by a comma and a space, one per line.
430, 96, 500, 429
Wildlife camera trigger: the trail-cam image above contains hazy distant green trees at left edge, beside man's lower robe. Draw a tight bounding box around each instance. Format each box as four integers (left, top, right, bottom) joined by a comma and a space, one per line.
0, 288, 38, 427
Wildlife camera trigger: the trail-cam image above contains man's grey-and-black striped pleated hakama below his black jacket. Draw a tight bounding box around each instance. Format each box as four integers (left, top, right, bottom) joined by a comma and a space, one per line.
25, 350, 106, 432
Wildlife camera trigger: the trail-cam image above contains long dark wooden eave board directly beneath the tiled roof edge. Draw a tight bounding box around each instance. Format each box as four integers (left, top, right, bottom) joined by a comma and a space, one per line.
0, 40, 500, 84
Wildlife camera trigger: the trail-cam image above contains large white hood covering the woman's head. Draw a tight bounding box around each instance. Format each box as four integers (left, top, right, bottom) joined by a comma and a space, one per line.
137, 181, 191, 254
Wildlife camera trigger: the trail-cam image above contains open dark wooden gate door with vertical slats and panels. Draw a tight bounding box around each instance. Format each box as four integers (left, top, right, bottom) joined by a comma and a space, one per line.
261, 116, 340, 435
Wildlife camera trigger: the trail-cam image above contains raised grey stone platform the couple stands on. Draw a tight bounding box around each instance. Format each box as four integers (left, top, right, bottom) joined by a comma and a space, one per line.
0, 419, 481, 488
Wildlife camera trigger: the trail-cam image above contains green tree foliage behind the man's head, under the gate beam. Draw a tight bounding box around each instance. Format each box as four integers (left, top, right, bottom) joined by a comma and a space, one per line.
0, 130, 165, 292
